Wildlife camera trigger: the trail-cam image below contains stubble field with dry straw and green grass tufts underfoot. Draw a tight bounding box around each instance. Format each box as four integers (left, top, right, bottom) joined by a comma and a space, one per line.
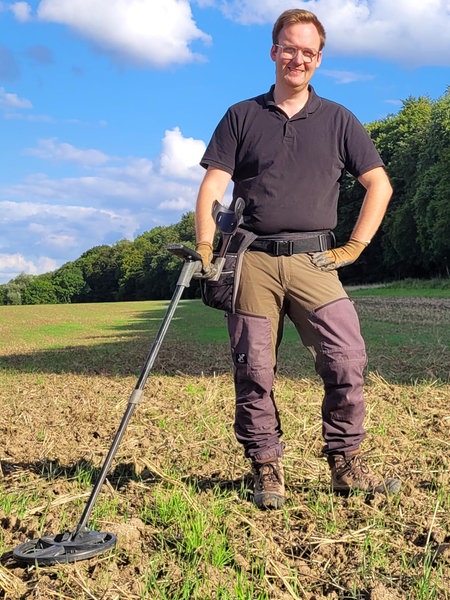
0, 290, 450, 600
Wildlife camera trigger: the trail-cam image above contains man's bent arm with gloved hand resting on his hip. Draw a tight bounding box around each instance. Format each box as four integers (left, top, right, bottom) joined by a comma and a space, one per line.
311, 167, 392, 271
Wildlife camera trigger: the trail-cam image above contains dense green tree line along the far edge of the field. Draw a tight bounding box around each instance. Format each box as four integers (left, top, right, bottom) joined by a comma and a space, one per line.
0, 88, 450, 304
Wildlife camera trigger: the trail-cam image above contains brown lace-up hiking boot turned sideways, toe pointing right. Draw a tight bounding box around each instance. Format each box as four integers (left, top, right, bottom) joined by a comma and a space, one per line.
327, 450, 401, 495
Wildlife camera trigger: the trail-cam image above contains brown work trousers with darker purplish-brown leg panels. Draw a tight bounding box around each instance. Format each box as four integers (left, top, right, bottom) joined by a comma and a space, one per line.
227, 251, 367, 460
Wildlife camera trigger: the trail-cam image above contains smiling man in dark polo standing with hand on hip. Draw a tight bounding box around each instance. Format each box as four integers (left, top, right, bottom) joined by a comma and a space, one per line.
196, 9, 400, 509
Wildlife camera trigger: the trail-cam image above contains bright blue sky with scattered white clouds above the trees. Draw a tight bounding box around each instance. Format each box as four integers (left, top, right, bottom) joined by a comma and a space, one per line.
0, 0, 450, 284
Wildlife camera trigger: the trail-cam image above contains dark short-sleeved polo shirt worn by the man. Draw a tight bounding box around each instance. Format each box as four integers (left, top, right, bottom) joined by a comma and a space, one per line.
201, 86, 383, 235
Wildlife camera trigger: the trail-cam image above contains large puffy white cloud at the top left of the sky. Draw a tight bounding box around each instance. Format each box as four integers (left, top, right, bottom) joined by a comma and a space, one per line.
37, 0, 210, 68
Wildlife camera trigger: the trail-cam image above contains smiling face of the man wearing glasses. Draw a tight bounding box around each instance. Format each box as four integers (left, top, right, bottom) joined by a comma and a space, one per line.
270, 23, 322, 91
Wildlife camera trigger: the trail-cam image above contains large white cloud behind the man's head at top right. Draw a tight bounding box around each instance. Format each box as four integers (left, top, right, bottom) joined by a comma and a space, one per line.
215, 0, 450, 67
